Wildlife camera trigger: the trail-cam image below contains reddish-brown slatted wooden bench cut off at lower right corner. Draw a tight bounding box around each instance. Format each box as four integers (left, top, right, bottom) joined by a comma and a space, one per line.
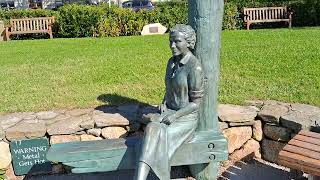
278, 130, 320, 176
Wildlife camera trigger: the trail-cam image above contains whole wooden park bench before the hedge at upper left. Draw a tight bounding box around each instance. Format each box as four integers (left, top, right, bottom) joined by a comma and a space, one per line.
6, 17, 55, 41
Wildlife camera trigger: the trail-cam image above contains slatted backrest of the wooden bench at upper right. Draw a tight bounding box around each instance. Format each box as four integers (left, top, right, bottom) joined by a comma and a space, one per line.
243, 7, 288, 22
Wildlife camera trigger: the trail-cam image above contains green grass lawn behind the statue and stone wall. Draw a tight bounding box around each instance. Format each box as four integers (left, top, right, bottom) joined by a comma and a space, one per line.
0, 28, 320, 113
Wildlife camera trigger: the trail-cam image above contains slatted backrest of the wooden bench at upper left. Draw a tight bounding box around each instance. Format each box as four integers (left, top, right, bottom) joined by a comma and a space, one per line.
10, 17, 55, 33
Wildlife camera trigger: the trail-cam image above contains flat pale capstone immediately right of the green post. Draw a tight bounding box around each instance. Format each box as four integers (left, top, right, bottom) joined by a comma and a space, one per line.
218, 104, 258, 123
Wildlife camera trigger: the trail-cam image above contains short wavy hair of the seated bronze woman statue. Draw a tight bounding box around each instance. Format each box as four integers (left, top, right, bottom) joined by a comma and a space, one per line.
170, 24, 196, 49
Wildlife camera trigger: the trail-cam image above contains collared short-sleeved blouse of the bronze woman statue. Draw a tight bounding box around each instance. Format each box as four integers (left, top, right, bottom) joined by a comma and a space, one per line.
165, 52, 204, 110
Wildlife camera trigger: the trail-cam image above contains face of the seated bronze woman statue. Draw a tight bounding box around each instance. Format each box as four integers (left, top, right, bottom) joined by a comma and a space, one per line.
170, 31, 189, 56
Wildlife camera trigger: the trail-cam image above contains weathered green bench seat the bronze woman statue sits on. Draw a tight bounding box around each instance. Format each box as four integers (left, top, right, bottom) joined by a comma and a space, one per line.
47, 131, 228, 173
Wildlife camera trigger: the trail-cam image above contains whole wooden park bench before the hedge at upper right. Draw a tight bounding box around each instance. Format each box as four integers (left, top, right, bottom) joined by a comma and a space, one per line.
243, 7, 292, 30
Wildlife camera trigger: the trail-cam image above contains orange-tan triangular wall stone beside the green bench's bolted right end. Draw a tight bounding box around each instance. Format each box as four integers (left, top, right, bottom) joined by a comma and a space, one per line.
223, 127, 252, 153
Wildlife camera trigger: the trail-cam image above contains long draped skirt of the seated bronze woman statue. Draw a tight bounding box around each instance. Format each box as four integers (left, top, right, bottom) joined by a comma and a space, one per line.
139, 110, 199, 180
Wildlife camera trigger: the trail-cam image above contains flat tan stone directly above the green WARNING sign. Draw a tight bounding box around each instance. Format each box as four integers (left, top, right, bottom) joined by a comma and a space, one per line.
6, 121, 47, 141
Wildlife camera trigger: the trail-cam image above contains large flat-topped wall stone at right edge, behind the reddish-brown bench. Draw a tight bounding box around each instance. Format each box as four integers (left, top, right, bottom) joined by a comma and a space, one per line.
280, 104, 320, 133
